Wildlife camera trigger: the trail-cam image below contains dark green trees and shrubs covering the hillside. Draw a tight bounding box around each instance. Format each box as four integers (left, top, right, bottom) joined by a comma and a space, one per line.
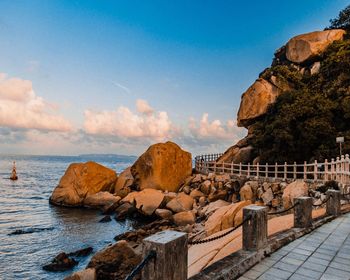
252, 36, 350, 162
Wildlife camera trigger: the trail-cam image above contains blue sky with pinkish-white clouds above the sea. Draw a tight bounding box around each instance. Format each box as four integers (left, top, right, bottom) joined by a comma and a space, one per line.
0, 0, 349, 155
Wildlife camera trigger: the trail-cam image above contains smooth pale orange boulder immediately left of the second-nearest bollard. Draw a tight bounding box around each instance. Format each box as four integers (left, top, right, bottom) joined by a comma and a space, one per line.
205, 201, 251, 236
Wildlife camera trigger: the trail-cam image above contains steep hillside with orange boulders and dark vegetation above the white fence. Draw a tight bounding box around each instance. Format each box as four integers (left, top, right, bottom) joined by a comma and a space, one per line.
219, 29, 350, 162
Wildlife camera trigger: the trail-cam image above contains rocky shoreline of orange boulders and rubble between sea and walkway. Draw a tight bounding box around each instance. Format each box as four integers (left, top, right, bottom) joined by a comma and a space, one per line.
45, 142, 333, 279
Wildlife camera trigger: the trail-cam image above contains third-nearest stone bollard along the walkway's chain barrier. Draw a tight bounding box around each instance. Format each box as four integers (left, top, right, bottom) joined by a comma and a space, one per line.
294, 196, 312, 228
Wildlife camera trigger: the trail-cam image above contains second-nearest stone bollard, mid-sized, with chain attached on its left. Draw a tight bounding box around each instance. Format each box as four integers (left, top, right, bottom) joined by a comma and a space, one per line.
242, 205, 267, 251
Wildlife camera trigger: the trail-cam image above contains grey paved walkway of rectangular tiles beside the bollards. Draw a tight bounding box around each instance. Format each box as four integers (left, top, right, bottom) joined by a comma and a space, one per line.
239, 213, 350, 280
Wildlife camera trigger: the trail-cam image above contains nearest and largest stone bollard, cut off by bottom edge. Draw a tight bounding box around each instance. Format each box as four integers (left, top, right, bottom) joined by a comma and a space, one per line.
142, 230, 188, 280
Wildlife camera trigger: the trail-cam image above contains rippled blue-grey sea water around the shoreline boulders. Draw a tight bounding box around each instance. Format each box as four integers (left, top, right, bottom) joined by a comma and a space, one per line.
0, 155, 135, 279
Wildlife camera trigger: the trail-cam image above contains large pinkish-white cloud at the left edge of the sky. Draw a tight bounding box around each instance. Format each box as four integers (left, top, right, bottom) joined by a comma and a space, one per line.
0, 73, 72, 131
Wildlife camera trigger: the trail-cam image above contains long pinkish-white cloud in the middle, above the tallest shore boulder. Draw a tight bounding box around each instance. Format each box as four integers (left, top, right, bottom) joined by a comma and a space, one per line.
84, 100, 175, 141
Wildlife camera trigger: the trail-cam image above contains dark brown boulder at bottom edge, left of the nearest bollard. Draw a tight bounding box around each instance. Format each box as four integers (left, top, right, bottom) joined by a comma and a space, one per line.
87, 240, 141, 280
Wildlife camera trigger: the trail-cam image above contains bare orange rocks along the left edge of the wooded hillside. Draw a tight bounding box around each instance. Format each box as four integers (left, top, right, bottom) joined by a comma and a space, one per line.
219, 29, 345, 163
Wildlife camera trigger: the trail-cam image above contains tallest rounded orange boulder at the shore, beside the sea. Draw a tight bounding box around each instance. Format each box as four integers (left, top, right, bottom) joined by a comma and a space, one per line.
131, 142, 192, 192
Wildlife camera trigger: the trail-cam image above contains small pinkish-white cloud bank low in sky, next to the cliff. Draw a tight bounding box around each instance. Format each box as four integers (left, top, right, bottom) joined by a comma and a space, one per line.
188, 113, 244, 141
